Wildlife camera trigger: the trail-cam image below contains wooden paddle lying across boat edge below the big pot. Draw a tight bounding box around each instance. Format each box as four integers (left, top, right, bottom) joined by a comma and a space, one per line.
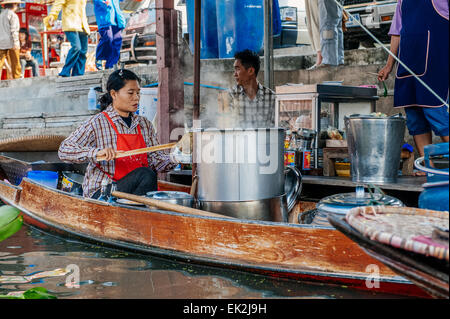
111, 191, 234, 219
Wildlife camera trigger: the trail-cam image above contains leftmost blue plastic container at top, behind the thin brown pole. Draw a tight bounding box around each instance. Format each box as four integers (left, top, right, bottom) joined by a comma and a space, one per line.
186, 0, 217, 59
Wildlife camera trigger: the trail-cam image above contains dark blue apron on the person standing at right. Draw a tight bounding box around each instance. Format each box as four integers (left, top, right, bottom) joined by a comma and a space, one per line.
394, 0, 449, 107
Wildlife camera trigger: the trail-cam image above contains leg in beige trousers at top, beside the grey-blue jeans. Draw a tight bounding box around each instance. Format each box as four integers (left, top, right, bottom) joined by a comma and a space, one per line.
305, 0, 322, 70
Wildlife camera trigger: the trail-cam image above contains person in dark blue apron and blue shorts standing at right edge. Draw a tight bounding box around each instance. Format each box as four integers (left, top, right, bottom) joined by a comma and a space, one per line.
378, 0, 449, 165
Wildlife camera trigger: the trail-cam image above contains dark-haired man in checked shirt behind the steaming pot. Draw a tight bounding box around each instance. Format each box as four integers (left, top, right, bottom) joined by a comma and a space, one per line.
219, 50, 275, 128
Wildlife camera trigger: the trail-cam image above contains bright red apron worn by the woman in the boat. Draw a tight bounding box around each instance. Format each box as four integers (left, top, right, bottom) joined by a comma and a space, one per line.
97, 112, 148, 182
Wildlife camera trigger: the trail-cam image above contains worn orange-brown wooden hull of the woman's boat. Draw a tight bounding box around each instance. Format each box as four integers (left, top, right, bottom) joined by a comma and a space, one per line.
0, 178, 428, 297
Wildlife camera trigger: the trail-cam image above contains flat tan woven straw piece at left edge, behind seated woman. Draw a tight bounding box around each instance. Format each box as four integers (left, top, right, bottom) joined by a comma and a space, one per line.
0, 135, 66, 152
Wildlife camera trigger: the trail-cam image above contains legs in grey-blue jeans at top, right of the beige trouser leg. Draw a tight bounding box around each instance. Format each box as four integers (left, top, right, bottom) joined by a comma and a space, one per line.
319, 0, 344, 66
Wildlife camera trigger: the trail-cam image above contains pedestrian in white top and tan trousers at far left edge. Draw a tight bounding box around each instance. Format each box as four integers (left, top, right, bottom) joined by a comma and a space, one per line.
0, 0, 22, 79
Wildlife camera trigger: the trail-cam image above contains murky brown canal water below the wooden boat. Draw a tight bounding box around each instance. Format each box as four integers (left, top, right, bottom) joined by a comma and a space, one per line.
0, 225, 408, 299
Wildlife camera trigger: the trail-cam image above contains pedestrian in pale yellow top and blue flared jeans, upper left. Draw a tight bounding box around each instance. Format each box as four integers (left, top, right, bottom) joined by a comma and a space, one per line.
44, 0, 90, 77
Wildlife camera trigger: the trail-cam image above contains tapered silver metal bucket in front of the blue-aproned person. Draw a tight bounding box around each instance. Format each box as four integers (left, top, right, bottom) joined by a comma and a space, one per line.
344, 114, 406, 184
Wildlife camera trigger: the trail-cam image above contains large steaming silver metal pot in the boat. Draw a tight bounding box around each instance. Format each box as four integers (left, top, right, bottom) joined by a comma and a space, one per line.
193, 128, 301, 222
